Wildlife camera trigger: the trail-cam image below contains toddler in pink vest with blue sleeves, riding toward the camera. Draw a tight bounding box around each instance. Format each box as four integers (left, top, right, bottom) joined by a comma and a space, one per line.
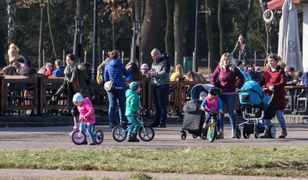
201, 88, 224, 139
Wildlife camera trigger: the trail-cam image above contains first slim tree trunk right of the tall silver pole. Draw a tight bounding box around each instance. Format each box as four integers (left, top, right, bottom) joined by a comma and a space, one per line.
204, 0, 214, 72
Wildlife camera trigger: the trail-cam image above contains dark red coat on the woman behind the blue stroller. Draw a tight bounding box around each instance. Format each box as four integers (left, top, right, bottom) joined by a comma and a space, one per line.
260, 66, 286, 110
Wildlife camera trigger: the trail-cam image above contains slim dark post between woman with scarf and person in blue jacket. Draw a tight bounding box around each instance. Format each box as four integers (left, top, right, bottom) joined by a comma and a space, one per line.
92, 0, 98, 80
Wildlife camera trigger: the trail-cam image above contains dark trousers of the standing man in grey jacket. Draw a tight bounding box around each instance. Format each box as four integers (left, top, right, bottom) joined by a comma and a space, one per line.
152, 84, 169, 126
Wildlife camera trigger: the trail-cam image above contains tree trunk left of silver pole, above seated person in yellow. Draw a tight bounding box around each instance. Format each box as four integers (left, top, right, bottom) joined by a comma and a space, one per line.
174, 0, 186, 65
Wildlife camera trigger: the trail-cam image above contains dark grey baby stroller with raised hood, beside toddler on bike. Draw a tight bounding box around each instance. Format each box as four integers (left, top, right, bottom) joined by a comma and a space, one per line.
181, 84, 214, 140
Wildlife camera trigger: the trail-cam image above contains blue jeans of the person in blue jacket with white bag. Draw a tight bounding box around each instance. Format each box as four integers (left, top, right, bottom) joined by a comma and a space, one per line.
108, 89, 127, 128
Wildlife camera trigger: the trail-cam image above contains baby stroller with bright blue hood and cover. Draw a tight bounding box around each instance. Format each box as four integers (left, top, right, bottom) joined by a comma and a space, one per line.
239, 80, 276, 139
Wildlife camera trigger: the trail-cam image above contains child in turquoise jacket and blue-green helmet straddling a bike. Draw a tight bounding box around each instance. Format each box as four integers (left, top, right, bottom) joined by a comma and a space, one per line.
125, 81, 141, 142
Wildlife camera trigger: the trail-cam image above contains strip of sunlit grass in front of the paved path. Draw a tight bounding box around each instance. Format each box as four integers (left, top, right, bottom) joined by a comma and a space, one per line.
0, 146, 308, 177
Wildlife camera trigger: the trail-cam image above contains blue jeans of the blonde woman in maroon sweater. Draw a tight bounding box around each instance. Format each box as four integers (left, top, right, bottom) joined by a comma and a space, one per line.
221, 94, 236, 129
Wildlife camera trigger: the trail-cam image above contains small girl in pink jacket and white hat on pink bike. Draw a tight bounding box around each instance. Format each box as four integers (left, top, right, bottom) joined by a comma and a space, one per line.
73, 93, 96, 145
